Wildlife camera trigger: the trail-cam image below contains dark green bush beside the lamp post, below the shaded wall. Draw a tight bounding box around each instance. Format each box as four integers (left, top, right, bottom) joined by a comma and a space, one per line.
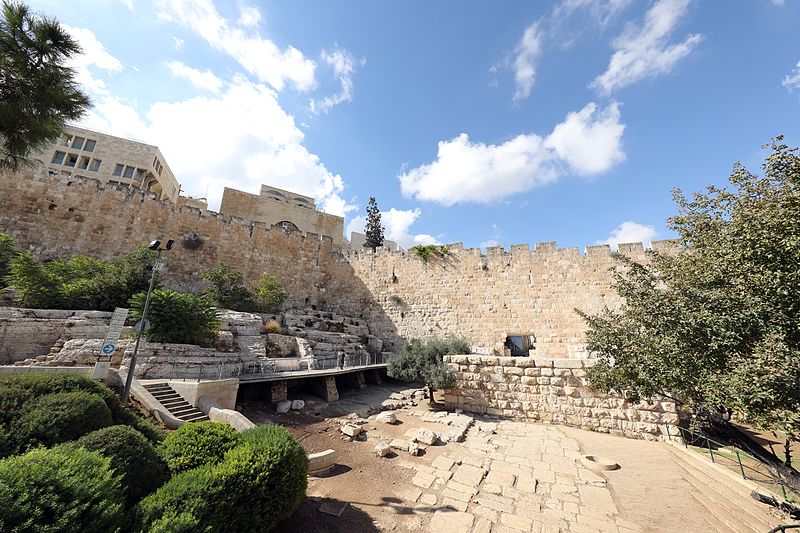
130, 289, 220, 346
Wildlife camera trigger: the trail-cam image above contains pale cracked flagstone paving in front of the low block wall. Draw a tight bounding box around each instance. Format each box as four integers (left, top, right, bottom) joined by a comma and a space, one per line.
390, 421, 641, 533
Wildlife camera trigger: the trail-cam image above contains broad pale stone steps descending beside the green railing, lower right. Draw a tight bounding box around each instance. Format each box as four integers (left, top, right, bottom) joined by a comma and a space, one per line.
673, 444, 778, 533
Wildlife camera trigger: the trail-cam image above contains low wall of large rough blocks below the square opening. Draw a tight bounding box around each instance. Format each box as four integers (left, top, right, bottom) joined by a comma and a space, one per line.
445, 355, 678, 440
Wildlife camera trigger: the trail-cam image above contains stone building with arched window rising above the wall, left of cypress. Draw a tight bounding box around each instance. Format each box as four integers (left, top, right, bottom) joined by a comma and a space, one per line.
219, 185, 346, 245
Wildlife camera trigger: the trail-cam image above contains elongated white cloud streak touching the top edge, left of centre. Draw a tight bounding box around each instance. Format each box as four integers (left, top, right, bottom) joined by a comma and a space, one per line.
158, 0, 316, 91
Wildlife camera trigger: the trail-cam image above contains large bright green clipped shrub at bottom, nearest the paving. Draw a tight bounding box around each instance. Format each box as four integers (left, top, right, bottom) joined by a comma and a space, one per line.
137, 425, 308, 532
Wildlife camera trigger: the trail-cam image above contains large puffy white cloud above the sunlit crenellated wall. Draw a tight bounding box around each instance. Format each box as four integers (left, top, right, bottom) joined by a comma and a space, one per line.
398, 103, 625, 206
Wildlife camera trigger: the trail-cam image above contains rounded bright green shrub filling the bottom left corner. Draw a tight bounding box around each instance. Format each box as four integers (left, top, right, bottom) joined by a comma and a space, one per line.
0, 445, 123, 533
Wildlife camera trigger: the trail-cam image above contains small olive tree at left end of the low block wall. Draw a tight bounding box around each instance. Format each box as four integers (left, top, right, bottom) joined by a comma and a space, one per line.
387, 337, 470, 402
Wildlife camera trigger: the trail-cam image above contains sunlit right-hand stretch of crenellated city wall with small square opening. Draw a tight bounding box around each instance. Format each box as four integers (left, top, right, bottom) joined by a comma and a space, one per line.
329, 241, 673, 359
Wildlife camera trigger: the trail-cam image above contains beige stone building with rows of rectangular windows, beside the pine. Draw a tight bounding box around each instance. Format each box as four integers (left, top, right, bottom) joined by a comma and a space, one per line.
33, 126, 180, 203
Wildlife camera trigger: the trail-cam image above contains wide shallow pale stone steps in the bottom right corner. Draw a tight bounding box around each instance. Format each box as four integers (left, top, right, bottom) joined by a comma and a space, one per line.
670, 446, 791, 533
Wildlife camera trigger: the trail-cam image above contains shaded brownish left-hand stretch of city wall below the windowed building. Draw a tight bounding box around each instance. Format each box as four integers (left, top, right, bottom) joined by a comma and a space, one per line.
0, 170, 338, 306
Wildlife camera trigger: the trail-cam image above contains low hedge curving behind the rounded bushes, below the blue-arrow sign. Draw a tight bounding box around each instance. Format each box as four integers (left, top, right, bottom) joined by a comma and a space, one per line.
0, 372, 164, 455
